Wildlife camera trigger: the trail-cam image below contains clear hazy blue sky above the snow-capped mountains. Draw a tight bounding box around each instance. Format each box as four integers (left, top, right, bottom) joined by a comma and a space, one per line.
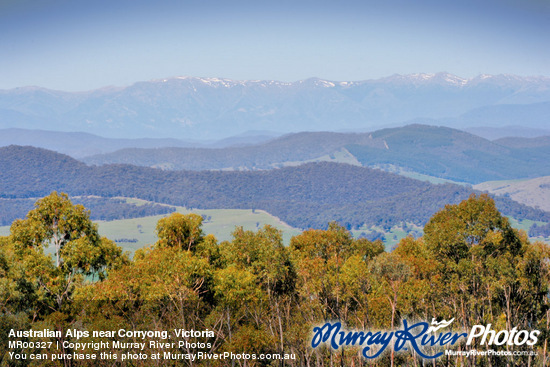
0, 0, 550, 90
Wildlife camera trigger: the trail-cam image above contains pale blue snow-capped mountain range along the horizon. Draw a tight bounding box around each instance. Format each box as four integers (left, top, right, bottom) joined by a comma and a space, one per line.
0, 73, 550, 141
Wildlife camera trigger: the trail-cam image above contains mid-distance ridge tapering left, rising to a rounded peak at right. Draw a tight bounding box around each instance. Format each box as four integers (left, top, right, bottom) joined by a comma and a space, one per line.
83, 124, 550, 184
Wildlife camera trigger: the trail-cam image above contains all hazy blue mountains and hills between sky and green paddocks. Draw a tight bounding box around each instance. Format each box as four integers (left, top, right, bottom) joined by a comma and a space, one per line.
0, 73, 550, 243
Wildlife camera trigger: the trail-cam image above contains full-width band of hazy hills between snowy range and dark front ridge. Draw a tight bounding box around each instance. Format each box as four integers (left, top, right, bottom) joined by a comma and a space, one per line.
0, 124, 550, 184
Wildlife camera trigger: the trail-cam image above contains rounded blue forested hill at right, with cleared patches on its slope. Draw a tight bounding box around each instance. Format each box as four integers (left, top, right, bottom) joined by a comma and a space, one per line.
347, 125, 550, 184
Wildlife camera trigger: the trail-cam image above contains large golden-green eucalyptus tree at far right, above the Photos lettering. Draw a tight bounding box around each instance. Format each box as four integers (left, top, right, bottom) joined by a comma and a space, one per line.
424, 194, 549, 364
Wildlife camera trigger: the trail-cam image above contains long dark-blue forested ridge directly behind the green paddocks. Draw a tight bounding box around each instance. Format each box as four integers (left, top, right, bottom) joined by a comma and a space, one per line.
0, 146, 550, 228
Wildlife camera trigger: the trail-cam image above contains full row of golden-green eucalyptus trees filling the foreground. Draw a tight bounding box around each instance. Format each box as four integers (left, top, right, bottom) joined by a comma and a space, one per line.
0, 192, 550, 366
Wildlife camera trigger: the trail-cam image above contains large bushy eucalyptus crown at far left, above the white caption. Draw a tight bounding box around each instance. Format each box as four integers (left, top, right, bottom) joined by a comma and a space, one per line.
9, 192, 125, 310
